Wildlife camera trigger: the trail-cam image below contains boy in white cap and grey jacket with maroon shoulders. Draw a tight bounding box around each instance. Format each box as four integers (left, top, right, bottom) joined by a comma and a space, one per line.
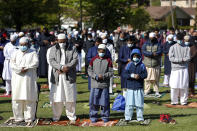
88, 44, 113, 123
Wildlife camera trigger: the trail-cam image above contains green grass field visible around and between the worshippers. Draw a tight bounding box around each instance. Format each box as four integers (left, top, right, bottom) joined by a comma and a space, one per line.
0, 68, 197, 131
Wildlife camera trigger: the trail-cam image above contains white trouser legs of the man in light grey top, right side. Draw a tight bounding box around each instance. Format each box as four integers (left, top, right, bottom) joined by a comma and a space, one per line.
171, 88, 188, 105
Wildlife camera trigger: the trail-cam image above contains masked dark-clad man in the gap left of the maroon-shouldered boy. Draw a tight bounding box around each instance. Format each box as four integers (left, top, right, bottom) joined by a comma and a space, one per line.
83, 34, 94, 75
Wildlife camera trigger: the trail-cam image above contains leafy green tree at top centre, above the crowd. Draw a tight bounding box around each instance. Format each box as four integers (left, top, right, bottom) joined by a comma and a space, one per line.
83, 0, 134, 30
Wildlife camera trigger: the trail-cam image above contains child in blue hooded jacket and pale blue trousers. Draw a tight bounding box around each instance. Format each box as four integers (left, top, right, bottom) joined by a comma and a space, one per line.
124, 49, 147, 122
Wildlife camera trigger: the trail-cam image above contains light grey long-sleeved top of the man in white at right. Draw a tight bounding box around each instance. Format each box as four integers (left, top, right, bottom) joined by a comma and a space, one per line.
169, 43, 190, 71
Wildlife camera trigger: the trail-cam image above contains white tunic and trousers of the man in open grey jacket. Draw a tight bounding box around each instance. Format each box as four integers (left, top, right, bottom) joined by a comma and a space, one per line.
50, 48, 77, 121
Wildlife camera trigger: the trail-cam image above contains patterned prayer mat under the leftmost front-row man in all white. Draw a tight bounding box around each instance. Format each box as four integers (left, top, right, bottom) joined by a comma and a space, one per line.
0, 117, 39, 127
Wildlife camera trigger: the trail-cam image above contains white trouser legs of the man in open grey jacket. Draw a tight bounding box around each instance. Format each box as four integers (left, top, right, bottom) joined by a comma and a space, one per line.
52, 102, 77, 121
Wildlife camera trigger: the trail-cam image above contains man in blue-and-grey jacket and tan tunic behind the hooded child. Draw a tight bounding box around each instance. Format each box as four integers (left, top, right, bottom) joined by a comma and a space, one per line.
142, 32, 162, 96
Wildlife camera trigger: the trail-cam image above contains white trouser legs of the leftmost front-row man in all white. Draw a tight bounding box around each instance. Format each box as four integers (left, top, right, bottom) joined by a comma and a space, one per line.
12, 100, 36, 122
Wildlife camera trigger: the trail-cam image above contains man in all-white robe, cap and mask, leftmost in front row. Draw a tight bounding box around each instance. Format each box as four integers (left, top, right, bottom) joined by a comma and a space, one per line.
10, 37, 39, 123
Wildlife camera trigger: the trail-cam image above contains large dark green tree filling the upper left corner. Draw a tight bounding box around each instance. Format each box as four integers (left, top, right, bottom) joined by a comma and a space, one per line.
0, 0, 58, 31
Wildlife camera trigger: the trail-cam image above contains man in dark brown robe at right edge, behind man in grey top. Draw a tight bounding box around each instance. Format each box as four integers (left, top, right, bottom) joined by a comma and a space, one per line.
184, 32, 197, 97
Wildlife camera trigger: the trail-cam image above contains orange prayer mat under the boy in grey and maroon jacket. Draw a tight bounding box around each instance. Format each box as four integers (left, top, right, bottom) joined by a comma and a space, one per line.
79, 119, 119, 127
